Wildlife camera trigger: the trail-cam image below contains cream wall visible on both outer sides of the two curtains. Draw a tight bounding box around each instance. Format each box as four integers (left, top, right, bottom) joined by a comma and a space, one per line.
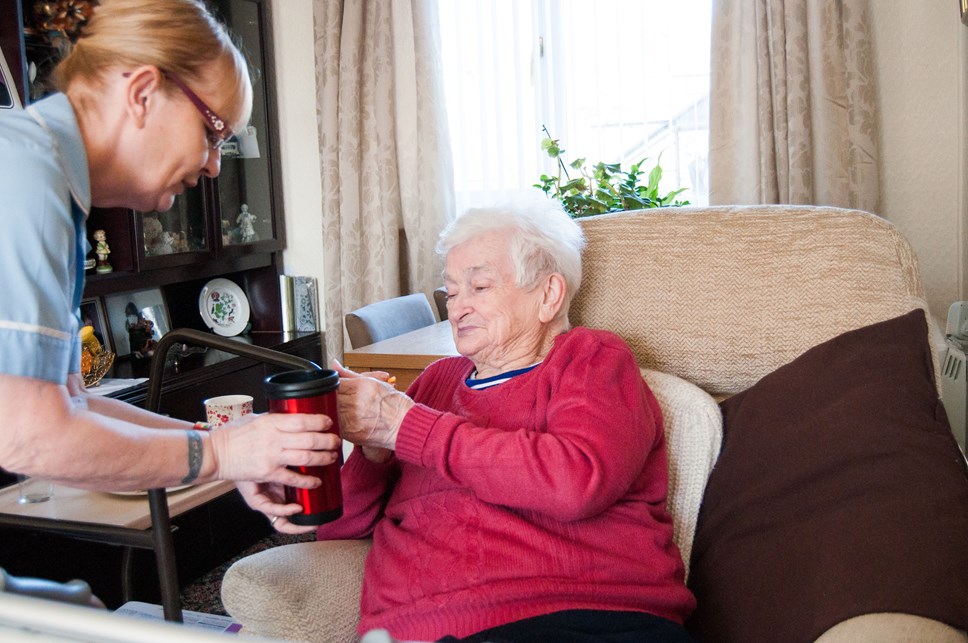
270, 0, 968, 338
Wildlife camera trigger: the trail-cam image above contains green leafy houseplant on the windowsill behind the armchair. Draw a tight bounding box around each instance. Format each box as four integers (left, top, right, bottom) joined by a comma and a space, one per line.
534, 128, 689, 218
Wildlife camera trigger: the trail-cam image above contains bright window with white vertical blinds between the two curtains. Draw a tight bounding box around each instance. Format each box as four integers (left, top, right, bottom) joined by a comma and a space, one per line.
439, 0, 711, 212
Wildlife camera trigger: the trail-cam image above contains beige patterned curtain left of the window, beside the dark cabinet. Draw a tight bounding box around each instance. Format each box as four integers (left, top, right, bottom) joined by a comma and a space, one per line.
314, 0, 454, 357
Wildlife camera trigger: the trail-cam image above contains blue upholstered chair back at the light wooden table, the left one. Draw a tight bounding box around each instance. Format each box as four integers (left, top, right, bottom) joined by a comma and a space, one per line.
344, 293, 437, 348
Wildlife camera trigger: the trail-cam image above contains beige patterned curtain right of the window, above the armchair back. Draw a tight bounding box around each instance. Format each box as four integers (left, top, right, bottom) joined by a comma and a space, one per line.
709, 0, 880, 212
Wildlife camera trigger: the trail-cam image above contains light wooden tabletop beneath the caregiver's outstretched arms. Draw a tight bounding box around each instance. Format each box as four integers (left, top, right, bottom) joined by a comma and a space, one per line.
0, 480, 235, 529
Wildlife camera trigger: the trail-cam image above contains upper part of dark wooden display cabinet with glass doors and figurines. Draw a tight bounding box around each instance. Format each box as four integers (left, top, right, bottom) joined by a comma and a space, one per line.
0, 0, 285, 342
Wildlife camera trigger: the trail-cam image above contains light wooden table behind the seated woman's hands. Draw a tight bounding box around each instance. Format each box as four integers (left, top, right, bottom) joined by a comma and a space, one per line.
343, 321, 458, 391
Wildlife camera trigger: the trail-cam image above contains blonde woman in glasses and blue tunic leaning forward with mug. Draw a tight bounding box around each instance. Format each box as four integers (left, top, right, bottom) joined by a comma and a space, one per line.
0, 0, 339, 508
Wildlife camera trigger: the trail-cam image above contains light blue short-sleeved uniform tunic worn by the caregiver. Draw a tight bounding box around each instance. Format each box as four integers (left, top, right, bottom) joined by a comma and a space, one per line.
0, 94, 91, 384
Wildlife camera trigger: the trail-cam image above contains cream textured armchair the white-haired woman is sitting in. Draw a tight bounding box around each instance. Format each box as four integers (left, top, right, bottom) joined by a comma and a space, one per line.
222, 206, 968, 643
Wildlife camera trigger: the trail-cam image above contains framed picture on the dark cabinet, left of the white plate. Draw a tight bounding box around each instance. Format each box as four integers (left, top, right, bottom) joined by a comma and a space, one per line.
104, 288, 171, 358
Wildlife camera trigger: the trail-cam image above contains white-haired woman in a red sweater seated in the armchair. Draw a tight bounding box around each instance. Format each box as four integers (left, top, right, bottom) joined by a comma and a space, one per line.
318, 201, 694, 643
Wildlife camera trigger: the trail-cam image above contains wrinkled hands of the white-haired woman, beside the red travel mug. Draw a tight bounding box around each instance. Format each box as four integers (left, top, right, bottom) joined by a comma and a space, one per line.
333, 360, 414, 462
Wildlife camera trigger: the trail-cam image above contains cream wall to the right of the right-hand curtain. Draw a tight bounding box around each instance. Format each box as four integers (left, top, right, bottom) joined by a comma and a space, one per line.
871, 0, 968, 325
